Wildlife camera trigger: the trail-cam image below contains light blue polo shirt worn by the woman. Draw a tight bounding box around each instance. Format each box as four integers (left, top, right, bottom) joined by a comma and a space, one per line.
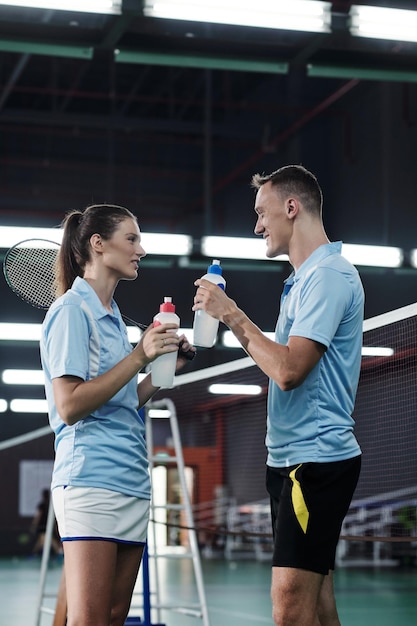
40, 278, 150, 499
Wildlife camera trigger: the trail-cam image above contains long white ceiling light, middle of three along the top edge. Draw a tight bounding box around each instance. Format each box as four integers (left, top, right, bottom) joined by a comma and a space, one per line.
144, 0, 331, 33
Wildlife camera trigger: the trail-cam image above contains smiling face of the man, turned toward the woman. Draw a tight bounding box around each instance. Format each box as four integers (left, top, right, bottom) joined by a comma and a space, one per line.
254, 181, 293, 259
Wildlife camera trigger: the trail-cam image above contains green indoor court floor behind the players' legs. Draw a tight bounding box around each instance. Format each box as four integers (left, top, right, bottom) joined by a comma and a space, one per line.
0, 558, 417, 626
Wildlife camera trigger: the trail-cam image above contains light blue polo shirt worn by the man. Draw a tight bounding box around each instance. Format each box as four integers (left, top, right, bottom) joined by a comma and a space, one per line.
266, 242, 364, 467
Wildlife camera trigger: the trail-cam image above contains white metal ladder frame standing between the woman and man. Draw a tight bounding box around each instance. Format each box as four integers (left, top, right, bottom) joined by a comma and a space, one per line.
141, 398, 210, 626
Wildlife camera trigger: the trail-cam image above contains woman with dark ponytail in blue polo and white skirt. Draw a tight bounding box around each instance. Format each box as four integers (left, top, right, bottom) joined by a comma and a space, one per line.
41, 205, 194, 626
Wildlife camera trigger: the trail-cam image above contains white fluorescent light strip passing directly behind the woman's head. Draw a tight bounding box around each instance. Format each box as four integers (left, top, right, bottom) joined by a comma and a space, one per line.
0, 226, 193, 256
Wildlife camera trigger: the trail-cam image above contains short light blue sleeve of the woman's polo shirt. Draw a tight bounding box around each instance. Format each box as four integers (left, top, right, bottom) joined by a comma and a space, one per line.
45, 304, 90, 380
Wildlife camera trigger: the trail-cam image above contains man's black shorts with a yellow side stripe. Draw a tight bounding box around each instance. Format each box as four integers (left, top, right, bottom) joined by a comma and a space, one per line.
266, 456, 361, 575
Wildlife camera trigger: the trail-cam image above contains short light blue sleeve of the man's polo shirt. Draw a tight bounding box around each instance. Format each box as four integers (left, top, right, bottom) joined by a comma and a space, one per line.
289, 267, 352, 348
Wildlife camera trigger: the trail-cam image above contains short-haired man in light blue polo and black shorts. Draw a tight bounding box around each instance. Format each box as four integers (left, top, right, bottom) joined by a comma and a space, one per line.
193, 165, 364, 626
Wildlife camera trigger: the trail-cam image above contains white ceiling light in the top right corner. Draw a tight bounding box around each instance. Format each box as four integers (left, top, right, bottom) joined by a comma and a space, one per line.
349, 4, 417, 42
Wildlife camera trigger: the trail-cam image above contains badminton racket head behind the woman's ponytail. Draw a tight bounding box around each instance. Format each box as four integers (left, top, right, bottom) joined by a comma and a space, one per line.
3, 239, 60, 309
